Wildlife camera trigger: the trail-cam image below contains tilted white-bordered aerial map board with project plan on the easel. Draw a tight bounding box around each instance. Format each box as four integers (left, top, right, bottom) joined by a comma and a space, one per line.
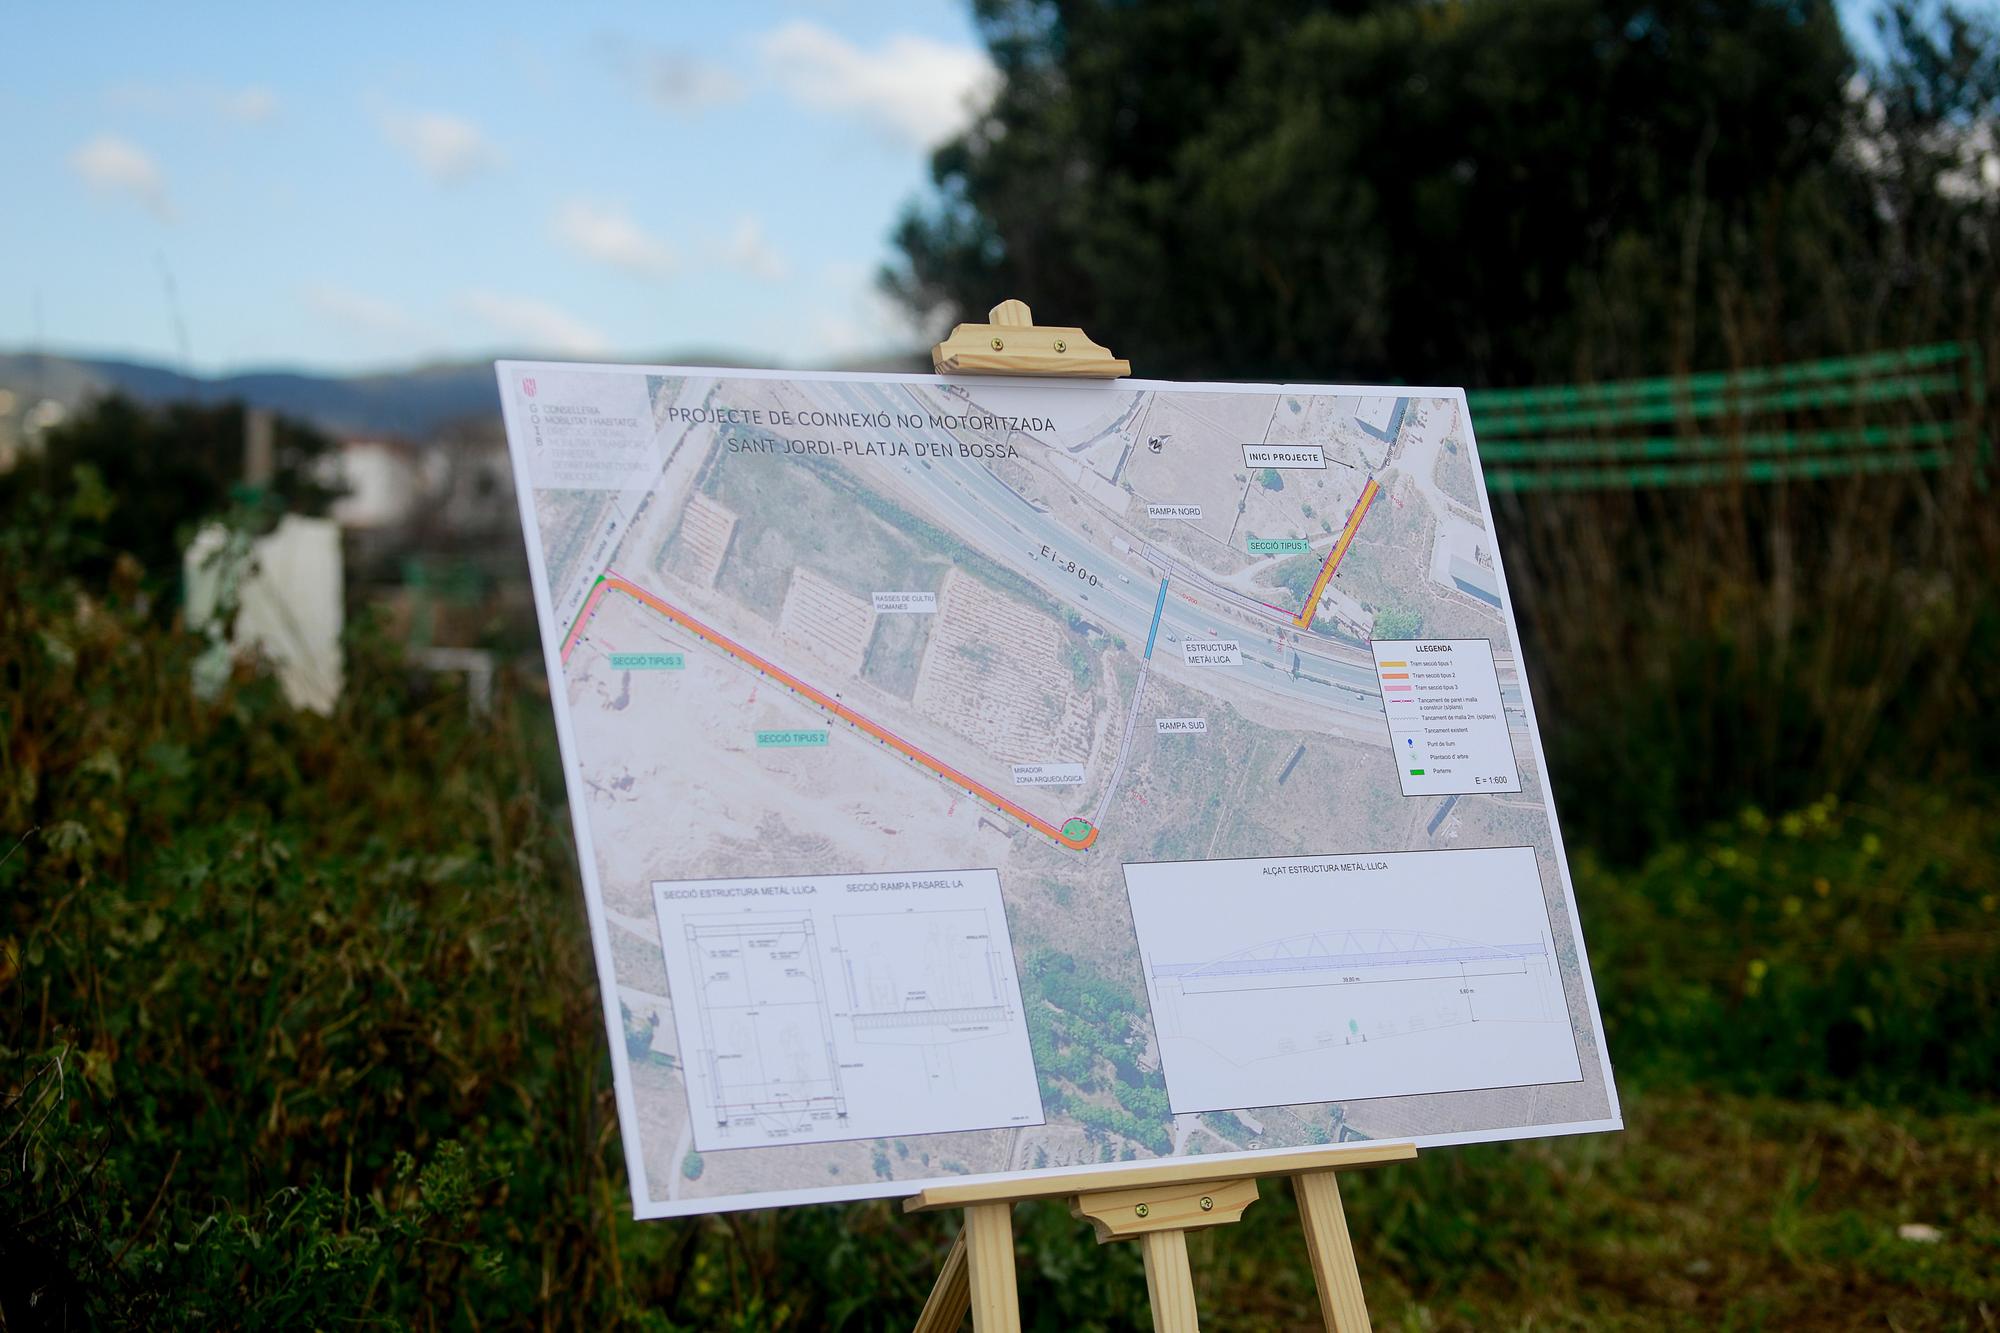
498, 362, 1620, 1217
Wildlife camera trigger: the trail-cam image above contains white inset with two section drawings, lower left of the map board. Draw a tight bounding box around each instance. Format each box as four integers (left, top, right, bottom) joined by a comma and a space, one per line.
652, 871, 1042, 1153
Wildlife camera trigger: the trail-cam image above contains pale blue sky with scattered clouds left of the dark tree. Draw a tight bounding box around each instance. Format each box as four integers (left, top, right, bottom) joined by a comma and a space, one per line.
0, 0, 1904, 370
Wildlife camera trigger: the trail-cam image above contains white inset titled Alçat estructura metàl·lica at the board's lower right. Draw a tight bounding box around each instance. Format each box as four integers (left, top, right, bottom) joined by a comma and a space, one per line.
1126, 847, 1580, 1113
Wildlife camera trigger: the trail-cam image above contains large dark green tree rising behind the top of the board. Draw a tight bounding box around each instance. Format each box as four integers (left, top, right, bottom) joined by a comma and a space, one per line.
884, 0, 1920, 382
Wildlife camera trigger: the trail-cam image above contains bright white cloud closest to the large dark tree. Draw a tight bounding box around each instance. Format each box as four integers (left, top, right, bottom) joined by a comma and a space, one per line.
758, 18, 998, 148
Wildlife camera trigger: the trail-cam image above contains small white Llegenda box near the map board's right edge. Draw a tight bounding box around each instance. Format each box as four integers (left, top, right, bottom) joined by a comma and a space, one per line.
1368, 638, 1520, 797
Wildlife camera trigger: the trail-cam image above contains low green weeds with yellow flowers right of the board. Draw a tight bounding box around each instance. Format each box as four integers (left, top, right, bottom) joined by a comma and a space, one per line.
1578, 795, 2000, 1107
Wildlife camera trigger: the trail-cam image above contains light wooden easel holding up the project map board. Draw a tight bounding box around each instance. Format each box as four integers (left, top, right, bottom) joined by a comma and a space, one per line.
904, 300, 1416, 1333
